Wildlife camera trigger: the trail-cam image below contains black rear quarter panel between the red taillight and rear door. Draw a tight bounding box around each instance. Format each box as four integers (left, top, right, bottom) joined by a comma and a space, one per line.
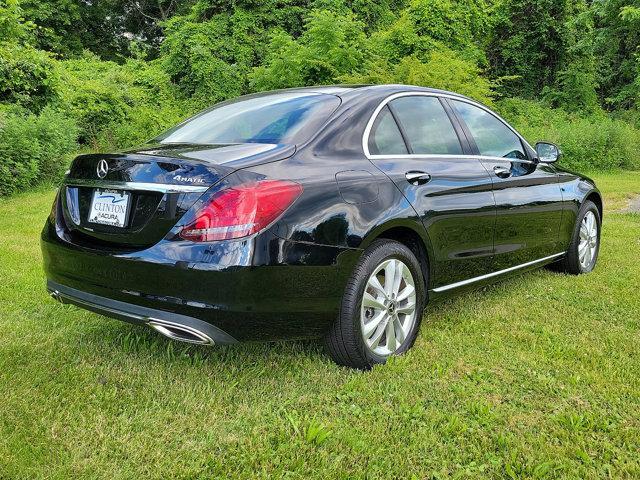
245, 152, 417, 250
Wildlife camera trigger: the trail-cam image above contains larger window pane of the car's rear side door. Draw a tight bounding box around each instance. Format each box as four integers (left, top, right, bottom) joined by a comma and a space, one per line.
391, 96, 462, 154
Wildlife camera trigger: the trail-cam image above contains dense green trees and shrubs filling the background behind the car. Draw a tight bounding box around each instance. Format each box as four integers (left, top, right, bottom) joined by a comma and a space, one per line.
0, 0, 640, 195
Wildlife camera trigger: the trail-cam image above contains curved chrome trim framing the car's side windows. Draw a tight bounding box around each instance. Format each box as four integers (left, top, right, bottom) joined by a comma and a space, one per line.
362, 92, 535, 163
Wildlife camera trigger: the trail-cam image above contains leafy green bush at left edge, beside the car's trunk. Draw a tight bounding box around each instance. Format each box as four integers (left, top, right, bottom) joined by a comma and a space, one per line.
0, 107, 77, 196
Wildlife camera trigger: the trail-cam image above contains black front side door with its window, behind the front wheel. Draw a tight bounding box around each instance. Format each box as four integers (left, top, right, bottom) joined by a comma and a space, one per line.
448, 99, 563, 271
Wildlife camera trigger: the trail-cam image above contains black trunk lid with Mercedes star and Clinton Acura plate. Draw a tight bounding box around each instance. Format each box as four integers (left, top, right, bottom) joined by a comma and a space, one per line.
60, 144, 295, 250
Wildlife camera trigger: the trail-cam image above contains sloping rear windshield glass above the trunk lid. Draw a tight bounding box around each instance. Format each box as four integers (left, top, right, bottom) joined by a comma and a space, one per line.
155, 92, 340, 145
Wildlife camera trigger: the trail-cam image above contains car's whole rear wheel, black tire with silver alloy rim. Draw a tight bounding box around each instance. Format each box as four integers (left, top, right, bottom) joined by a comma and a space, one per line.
325, 239, 426, 370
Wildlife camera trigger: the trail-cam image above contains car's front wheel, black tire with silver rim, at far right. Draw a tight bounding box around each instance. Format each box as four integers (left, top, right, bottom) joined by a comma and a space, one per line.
552, 200, 602, 275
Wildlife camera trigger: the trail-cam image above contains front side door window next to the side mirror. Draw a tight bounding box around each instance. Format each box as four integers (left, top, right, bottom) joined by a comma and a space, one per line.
452, 100, 527, 159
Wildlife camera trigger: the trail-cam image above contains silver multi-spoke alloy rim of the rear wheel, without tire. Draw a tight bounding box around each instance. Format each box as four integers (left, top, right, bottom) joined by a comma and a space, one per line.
360, 258, 416, 357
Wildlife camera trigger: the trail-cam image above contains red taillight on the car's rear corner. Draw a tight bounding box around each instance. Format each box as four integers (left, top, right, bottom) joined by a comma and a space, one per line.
180, 180, 302, 242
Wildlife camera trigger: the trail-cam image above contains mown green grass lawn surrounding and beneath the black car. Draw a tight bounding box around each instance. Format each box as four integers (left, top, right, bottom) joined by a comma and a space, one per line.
0, 172, 640, 480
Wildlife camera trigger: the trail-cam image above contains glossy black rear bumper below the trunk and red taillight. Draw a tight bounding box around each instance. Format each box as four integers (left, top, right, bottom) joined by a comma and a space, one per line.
41, 222, 361, 344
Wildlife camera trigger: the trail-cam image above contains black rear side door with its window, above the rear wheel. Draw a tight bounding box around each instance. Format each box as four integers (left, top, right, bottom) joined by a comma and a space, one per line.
366, 93, 495, 288
